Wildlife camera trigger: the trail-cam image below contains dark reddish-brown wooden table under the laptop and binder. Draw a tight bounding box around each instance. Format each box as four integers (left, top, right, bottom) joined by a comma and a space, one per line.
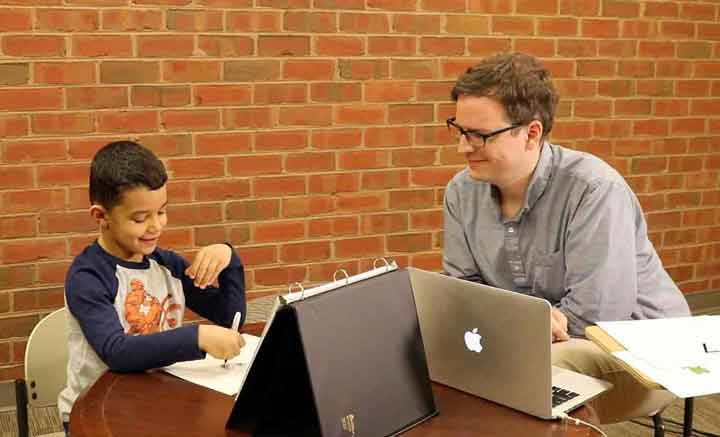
70, 325, 597, 437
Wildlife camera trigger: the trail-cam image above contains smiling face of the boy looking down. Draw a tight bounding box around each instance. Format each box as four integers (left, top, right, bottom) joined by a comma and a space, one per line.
91, 185, 167, 261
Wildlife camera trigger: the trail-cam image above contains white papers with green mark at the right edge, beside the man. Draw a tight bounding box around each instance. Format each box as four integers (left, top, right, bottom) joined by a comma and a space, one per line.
598, 316, 720, 397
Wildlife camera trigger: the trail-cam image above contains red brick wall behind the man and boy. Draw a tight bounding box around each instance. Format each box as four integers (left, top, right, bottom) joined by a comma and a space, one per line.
0, 0, 720, 380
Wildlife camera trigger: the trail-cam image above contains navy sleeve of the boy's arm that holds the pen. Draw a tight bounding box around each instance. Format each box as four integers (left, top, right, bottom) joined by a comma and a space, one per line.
66, 269, 205, 372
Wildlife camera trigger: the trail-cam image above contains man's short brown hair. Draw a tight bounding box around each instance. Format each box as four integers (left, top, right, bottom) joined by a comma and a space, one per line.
452, 53, 558, 137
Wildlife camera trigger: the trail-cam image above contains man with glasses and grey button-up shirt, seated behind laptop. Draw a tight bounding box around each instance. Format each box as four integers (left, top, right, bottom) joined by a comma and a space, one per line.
443, 53, 690, 423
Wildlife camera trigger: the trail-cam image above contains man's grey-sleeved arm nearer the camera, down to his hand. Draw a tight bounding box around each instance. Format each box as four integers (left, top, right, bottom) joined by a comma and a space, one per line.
559, 182, 640, 336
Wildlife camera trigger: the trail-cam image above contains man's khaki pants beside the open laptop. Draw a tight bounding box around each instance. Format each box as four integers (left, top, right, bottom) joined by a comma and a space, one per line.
551, 338, 675, 423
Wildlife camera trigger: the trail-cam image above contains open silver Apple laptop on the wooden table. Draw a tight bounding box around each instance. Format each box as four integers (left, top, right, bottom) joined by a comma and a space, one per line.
408, 268, 612, 419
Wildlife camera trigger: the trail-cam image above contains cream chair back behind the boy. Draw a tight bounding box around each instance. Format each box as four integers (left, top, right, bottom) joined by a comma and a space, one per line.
25, 308, 68, 407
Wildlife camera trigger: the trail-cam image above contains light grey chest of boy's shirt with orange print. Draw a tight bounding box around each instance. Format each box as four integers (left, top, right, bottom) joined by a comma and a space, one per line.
115, 260, 185, 335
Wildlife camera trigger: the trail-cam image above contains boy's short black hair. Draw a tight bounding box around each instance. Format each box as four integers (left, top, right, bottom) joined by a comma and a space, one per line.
89, 141, 167, 211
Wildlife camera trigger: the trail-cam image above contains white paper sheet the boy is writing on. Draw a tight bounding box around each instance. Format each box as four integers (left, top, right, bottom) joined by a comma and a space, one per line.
162, 334, 260, 396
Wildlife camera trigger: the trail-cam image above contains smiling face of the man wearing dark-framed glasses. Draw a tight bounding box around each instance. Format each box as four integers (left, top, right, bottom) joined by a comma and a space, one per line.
455, 96, 531, 188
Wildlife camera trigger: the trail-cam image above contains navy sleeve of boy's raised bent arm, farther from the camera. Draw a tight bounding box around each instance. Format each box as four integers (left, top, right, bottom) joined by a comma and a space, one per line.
158, 243, 247, 328
